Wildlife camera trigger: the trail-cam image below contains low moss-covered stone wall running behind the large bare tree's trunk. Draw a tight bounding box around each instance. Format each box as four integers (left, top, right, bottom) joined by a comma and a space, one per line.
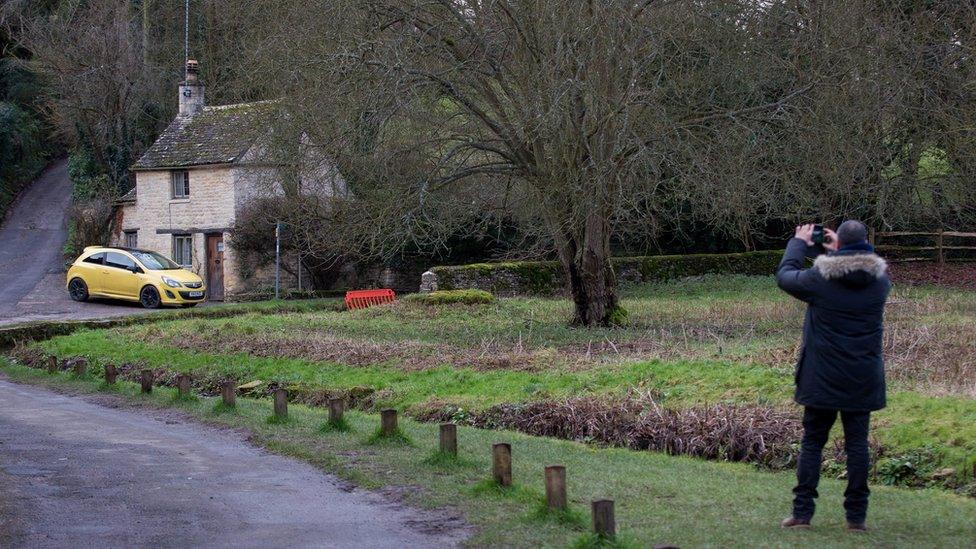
431, 250, 783, 295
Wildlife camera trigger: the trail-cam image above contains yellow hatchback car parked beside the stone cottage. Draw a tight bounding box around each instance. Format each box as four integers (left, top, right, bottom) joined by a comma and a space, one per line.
67, 246, 207, 309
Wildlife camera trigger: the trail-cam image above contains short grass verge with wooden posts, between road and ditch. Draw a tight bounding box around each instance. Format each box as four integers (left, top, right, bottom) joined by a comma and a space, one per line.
2, 365, 976, 547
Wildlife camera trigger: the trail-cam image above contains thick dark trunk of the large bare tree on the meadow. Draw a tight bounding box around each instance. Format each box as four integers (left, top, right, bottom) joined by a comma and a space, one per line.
556, 212, 620, 326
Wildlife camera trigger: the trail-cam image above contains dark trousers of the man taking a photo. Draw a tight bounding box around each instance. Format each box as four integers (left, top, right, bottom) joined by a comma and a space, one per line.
793, 407, 871, 523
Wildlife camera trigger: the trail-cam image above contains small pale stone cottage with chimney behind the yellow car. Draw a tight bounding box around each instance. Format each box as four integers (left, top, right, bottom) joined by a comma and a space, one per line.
114, 60, 341, 300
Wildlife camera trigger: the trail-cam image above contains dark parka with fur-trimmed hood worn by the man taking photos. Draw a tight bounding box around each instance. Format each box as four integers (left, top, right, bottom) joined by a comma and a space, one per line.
776, 238, 891, 412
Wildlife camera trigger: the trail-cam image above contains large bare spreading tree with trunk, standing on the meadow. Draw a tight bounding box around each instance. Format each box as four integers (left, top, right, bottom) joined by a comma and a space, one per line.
258, 0, 832, 325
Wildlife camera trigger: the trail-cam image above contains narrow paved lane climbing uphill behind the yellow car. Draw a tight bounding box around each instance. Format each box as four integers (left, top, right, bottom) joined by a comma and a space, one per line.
0, 160, 166, 325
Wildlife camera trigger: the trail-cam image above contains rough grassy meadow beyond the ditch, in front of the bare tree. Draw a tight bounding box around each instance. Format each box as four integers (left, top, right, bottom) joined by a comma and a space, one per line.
13, 276, 976, 480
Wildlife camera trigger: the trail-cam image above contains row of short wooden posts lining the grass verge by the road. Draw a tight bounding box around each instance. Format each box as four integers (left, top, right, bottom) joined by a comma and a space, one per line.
48, 357, 617, 538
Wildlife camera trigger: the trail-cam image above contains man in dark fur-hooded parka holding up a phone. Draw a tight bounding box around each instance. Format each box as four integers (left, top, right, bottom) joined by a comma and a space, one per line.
776, 220, 891, 531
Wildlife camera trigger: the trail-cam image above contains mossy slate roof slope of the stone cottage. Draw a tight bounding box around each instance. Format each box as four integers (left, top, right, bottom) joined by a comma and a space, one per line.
132, 101, 278, 170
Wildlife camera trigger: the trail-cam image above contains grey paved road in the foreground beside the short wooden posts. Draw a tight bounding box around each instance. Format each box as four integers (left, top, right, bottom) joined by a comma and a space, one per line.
0, 378, 464, 548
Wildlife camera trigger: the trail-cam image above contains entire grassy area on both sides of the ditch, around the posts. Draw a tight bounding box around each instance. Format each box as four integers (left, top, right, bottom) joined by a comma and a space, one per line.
7, 277, 976, 546
